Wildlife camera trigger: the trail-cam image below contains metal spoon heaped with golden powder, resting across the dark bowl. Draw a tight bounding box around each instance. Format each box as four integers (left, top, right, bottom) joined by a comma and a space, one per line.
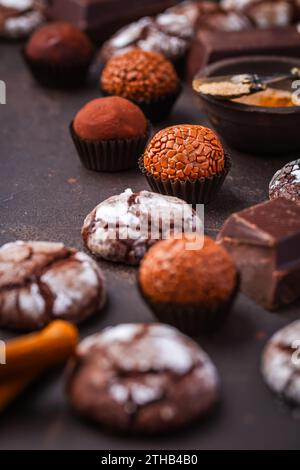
193, 67, 300, 100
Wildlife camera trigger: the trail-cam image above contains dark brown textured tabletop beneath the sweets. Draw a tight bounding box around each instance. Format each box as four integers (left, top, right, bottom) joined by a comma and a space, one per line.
0, 44, 300, 450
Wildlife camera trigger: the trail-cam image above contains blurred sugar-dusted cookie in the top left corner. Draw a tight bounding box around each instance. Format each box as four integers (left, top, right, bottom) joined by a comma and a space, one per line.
0, 0, 45, 39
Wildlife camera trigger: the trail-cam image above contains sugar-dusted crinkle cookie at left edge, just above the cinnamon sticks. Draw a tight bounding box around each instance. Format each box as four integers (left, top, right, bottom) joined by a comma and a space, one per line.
0, 241, 105, 330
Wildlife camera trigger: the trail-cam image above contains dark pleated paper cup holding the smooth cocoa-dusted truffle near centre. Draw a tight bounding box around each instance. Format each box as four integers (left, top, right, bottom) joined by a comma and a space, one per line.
70, 121, 152, 172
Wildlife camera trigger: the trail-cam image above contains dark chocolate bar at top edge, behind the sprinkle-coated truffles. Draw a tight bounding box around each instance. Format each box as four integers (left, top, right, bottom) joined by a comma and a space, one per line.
48, 0, 177, 42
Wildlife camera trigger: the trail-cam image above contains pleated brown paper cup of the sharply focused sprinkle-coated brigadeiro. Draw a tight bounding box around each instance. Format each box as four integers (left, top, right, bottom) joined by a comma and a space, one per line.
139, 154, 231, 206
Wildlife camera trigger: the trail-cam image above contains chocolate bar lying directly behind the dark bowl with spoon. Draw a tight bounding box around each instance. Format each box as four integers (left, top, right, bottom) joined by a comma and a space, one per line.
187, 26, 300, 80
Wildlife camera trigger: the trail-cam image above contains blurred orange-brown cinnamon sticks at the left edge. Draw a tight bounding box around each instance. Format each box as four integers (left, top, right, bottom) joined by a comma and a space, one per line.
0, 320, 78, 388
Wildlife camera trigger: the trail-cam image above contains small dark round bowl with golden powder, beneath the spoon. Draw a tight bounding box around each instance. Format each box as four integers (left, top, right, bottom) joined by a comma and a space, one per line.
195, 56, 300, 155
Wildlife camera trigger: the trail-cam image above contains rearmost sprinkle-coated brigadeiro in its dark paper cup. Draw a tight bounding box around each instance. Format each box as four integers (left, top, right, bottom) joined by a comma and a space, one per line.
100, 49, 181, 122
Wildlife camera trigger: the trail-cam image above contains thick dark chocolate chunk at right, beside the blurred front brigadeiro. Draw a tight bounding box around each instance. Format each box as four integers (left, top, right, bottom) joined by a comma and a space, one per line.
218, 198, 300, 310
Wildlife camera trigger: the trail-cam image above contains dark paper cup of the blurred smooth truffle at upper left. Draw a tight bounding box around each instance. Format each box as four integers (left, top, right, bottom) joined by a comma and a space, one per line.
22, 49, 91, 89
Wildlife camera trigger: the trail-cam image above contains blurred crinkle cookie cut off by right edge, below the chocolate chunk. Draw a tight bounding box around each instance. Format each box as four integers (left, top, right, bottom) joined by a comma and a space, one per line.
262, 320, 300, 405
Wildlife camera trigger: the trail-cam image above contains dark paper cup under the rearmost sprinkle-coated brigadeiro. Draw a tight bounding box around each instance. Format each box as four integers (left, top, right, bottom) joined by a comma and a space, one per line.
101, 85, 182, 124
